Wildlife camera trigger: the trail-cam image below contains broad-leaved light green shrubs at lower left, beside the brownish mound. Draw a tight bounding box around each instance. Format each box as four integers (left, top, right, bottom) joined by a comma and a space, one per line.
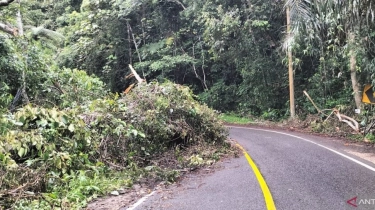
0, 99, 135, 207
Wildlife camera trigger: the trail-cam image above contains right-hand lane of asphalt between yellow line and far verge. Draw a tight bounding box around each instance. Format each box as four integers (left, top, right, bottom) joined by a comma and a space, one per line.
230, 128, 375, 210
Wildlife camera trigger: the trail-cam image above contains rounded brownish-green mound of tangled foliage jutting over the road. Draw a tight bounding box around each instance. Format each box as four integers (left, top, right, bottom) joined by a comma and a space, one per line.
121, 82, 227, 159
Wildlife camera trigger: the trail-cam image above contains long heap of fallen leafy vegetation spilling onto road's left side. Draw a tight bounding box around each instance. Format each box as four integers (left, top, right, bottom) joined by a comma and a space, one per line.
0, 83, 227, 209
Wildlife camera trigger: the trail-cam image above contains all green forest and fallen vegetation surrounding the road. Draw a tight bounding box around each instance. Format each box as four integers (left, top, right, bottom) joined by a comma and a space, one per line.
0, 0, 375, 209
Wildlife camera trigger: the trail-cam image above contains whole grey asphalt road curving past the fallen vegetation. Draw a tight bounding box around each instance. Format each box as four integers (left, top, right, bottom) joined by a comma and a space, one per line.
130, 128, 375, 210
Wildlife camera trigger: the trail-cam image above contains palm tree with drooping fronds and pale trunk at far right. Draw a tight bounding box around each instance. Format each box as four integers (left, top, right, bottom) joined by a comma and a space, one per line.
286, 0, 374, 108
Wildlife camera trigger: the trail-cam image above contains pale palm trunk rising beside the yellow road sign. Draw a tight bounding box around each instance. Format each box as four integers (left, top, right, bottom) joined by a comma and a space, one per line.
349, 32, 361, 109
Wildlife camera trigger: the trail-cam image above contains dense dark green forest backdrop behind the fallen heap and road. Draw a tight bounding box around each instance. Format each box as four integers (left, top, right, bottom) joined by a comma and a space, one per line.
0, 0, 374, 119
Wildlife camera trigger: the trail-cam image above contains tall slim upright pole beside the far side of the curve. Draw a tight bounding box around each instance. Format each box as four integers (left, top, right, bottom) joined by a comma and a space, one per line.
286, 6, 296, 119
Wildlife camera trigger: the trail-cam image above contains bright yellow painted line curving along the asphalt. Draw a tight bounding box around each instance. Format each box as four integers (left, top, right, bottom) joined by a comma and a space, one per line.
237, 144, 276, 210
